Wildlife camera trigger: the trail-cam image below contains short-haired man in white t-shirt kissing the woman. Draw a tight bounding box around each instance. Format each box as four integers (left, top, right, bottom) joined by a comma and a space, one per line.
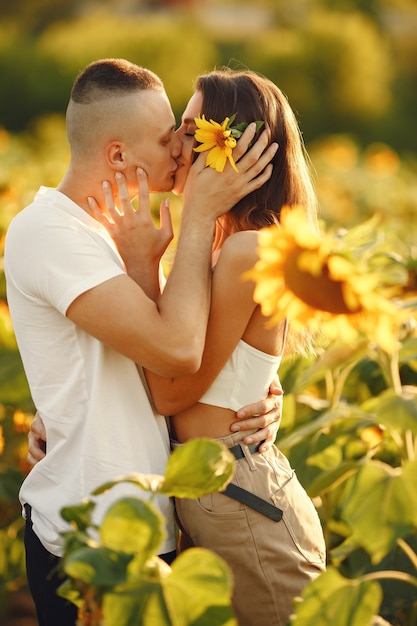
5, 59, 276, 626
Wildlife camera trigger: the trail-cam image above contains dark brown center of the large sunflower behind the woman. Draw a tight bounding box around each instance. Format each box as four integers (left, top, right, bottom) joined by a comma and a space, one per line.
284, 249, 360, 315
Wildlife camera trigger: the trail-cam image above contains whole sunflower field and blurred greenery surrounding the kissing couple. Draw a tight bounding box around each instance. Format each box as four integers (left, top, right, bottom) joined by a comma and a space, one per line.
0, 0, 417, 626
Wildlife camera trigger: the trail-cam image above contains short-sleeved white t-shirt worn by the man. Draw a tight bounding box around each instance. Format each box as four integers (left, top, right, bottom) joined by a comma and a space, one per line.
5, 187, 175, 556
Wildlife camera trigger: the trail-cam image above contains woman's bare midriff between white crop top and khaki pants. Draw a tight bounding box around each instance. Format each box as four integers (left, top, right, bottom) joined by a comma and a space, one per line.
171, 402, 237, 443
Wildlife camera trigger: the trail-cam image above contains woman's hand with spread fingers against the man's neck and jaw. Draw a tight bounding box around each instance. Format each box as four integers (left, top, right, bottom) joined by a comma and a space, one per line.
88, 168, 174, 299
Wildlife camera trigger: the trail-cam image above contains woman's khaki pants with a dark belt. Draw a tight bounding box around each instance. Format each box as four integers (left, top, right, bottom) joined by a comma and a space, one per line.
173, 433, 326, 626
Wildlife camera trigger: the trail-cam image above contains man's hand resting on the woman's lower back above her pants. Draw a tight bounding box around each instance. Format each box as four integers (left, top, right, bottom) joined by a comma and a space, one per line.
231, 376, 283, 454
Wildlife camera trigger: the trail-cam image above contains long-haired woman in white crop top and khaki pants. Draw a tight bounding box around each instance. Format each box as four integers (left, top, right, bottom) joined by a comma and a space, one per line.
100, 70, 325, 626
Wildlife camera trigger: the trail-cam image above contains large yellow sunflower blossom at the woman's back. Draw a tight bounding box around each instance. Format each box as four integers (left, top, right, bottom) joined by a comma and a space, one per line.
245, 207, 410, 352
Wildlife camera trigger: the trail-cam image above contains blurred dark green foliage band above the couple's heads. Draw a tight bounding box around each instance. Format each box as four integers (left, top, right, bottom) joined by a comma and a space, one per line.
0, 0, 417, 151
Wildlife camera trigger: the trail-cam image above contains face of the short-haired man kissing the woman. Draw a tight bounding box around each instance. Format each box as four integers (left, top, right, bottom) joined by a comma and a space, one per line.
124, 90, 181, 192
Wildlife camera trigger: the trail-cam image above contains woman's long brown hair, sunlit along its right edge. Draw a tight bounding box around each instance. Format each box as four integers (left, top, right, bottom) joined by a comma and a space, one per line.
196, 68, 317, 230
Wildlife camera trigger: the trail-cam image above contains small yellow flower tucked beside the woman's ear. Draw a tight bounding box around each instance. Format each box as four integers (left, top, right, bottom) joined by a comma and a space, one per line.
194, 115, 238, 172
